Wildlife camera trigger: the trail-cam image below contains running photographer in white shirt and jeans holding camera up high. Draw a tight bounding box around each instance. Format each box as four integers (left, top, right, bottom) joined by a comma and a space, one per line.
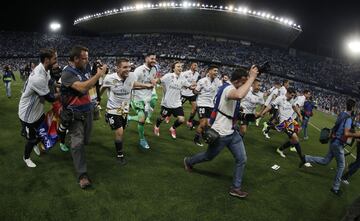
184, 65, 259, 198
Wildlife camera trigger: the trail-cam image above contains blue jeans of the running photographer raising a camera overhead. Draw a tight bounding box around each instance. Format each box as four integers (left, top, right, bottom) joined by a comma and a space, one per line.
186, 131, 247, 188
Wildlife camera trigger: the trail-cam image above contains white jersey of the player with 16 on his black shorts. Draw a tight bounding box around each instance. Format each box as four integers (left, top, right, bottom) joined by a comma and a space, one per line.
103, 73, 136, 115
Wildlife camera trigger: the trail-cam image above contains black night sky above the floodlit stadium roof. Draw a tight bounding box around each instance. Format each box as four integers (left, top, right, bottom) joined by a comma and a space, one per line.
0, 0, 360, 57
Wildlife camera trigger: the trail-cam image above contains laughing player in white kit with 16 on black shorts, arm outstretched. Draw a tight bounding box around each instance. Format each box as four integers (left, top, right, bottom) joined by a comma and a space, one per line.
101, 58, 153, 165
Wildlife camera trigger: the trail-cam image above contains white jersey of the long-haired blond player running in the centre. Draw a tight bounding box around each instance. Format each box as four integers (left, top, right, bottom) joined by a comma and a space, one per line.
160, 73, 191, 108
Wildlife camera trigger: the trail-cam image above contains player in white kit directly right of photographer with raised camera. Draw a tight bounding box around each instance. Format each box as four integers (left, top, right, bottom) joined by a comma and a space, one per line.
240, 79, 264, 138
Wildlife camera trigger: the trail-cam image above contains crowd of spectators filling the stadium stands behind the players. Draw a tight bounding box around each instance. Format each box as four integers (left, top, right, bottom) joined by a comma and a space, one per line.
0, 32, 360, 113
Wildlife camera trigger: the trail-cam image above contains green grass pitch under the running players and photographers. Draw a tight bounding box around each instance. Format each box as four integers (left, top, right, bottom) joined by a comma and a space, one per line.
0, 72, 360, 220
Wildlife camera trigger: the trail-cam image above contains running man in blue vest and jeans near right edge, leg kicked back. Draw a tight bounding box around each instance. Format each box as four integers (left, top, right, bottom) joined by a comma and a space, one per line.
304, 99, 360, 195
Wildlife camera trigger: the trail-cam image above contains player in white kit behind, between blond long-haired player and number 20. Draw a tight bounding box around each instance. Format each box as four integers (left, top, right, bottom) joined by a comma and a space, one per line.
181, 62, 200, 128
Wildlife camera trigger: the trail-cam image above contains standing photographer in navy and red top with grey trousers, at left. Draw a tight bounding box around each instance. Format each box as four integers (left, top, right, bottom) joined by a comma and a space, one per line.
60, 46, 107, 189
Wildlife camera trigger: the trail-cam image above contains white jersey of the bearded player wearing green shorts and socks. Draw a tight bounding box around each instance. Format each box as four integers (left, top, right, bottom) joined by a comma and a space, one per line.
133, 64, 156, 101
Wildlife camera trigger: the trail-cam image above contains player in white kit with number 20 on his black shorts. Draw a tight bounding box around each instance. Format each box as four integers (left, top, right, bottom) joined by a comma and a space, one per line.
194, 65, 222, 146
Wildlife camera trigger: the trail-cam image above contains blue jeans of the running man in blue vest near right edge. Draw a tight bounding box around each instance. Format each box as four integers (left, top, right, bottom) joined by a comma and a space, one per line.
305, 143, 345, 190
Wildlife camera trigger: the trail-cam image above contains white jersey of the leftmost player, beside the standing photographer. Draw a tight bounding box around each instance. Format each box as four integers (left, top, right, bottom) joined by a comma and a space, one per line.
18, 63, 51, 123
